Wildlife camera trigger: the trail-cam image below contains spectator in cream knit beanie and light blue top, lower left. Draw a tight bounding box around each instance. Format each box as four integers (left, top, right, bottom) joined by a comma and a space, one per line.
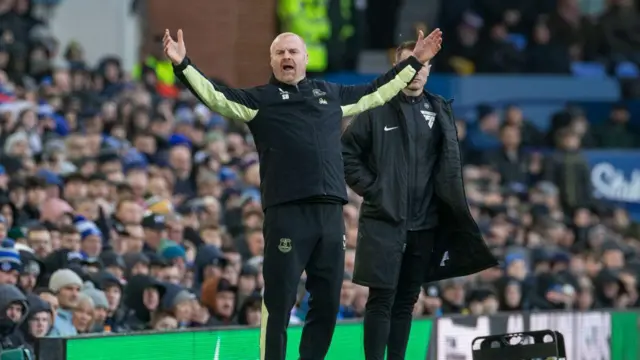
49, 269, 82, 336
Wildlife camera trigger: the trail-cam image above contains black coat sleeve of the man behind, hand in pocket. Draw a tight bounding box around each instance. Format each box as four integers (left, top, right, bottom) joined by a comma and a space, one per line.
342, 112, 376, 196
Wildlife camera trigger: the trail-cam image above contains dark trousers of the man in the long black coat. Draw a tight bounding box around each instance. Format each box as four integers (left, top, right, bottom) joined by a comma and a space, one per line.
364, 230, 435, 360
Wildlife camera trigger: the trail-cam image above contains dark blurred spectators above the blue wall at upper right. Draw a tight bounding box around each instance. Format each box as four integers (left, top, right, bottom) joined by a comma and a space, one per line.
438, 0, 640, 74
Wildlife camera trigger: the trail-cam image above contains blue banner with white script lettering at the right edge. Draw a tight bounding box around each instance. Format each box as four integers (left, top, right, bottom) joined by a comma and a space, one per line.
584, 151, 640, 221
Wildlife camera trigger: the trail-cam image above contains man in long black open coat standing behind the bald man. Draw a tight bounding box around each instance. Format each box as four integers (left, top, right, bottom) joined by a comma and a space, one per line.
342, 42, 498, 360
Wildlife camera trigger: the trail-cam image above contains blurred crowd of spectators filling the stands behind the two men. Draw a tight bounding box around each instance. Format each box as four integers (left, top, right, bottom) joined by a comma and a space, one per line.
0, 0, 640, 352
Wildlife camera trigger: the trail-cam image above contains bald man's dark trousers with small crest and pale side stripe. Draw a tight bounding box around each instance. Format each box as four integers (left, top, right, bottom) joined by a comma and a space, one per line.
260, 203, 346, 360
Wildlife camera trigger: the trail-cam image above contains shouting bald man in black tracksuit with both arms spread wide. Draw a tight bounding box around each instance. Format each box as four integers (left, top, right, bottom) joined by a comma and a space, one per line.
164, 29, 442, 360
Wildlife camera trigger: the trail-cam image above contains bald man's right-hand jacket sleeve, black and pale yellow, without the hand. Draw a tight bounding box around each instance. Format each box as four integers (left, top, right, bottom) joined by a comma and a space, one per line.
339, 56, 423, 117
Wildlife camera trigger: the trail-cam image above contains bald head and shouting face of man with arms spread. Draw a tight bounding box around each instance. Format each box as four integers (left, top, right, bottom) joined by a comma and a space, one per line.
271, 34, 309, 85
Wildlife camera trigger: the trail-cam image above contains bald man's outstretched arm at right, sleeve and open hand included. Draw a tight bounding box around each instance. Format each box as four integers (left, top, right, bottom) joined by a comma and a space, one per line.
340, 29, 442, 117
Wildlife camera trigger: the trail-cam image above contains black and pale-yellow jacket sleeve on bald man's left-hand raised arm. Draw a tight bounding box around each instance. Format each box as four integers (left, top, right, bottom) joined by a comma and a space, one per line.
173, 57, 259, 122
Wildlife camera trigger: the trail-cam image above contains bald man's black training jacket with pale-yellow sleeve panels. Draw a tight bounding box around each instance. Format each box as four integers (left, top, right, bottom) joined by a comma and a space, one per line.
174, 56, 422, 209
